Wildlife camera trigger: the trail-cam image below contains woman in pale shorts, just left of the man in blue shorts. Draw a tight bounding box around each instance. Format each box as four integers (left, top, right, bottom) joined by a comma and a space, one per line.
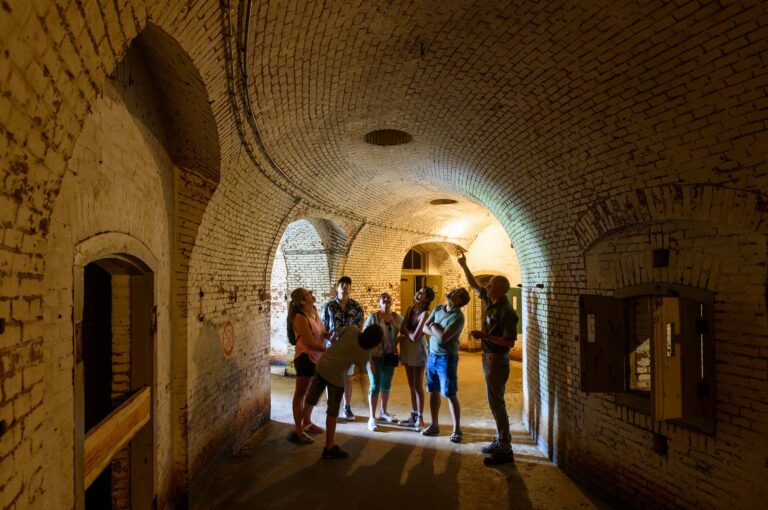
400, 287, 435, 428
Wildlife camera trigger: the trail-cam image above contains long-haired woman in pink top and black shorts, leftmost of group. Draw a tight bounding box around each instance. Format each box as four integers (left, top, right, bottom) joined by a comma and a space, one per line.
287, 287, 329, 444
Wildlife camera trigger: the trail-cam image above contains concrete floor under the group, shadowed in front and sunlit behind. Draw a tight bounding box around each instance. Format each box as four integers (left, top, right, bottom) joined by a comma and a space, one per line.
191, 353, 610, 510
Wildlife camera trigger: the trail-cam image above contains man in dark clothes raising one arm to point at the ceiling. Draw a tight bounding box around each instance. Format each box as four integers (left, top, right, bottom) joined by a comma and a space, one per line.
458, 253, 519, 465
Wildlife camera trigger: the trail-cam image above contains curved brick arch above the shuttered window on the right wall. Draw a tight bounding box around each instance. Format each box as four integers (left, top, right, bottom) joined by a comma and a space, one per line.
572, 184, 768, 251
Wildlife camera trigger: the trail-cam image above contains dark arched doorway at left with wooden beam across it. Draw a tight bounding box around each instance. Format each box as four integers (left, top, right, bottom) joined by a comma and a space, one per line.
75, 255, 155, 510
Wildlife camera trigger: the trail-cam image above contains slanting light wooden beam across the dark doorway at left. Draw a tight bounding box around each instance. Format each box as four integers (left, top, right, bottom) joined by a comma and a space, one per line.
85, 386, 151, 489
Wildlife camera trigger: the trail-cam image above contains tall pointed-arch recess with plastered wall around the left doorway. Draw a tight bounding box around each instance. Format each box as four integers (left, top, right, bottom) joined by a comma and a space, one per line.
38, 24, 220, 507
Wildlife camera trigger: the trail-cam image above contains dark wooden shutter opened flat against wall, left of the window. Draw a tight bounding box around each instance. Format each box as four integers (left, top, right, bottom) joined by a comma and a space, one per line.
579, 295, 627, 393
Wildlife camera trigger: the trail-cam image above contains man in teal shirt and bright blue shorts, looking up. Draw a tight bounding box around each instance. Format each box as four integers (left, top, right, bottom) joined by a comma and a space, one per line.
421, 287, 469, 443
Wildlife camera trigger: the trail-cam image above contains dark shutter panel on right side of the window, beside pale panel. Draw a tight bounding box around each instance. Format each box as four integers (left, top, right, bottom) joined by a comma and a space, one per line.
680, 299, 715, 431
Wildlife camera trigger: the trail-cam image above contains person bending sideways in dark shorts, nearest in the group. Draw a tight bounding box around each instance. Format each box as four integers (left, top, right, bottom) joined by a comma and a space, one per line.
305, 324, 384, 459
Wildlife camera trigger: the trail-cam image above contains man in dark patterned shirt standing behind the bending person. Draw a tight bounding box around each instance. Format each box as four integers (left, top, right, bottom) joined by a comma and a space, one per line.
321, 276, 364, 421
